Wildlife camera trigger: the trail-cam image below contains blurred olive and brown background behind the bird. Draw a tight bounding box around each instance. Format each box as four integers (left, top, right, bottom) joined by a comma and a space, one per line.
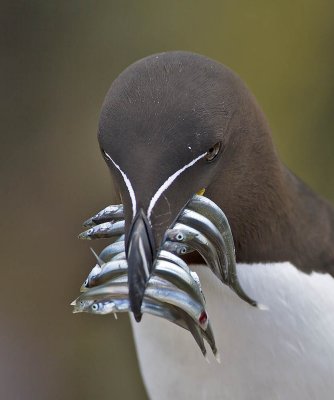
0, 0, 334, 400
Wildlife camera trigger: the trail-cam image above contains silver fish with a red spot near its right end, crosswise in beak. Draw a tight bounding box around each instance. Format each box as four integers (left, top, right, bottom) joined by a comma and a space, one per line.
77, 276, 208, 330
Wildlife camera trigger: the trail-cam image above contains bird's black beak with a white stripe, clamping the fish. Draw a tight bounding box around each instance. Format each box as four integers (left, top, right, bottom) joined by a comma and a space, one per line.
126, 209, 156, 322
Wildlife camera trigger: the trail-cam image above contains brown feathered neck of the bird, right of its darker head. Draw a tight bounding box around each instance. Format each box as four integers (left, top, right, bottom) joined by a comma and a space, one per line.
207, 97, 334, 276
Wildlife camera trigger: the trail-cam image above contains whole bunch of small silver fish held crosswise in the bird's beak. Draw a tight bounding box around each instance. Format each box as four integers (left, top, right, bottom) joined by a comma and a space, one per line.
73, 195, 256, 360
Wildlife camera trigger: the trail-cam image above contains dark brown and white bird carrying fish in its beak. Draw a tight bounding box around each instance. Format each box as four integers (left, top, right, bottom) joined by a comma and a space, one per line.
98, 51, 334, 400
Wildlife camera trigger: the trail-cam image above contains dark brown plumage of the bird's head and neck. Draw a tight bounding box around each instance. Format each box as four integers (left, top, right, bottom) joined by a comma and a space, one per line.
99, 52, 334, 282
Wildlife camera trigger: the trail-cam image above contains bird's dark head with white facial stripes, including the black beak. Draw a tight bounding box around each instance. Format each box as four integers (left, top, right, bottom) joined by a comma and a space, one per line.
98, 52, 258, 321
